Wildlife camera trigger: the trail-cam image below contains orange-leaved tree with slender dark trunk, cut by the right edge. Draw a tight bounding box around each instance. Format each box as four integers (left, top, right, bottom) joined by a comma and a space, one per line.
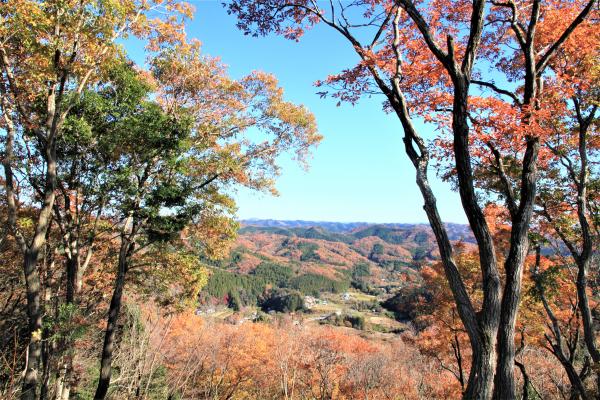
537, 23, 600, 397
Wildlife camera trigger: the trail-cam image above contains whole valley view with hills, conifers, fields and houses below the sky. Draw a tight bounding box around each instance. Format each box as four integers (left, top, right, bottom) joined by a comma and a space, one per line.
197, 220, 473, 334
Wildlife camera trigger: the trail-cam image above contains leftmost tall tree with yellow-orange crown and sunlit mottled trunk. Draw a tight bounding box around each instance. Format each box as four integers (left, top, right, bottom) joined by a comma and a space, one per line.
0, 0, 189, 399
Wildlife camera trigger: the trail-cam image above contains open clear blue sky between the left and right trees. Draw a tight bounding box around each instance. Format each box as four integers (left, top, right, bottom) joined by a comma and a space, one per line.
138, 0, 466, 223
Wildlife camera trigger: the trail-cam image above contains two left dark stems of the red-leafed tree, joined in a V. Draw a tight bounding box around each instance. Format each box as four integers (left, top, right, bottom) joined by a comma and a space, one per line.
386, 10, 500, 399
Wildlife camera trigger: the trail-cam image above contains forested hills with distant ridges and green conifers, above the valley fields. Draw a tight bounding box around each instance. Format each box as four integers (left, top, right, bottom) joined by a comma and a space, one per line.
202, 220, 473, 305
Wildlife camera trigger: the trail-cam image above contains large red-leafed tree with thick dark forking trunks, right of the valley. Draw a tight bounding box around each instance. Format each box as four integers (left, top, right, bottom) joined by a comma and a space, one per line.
227, 0, 596, 399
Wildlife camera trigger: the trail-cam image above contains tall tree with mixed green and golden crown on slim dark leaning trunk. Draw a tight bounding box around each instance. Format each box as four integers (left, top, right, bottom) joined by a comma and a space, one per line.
54, 43, 321, 399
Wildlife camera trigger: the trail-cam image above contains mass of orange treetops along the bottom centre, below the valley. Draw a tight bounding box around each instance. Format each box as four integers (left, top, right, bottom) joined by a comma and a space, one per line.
154, 313, 448, 400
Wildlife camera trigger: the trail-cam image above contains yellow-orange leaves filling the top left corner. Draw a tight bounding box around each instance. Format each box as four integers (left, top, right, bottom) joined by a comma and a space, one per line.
0, 0, 192, 123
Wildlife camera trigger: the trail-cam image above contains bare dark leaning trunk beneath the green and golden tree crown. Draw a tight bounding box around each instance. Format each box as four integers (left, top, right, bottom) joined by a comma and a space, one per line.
94, 238, 133, 400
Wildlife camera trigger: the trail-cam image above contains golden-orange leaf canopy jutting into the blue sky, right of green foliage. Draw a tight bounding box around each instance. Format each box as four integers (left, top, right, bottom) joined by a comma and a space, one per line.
152, 41, 322, 197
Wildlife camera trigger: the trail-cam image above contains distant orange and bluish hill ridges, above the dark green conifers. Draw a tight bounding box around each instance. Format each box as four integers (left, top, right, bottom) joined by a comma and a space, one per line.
210, 219, 474, 289
